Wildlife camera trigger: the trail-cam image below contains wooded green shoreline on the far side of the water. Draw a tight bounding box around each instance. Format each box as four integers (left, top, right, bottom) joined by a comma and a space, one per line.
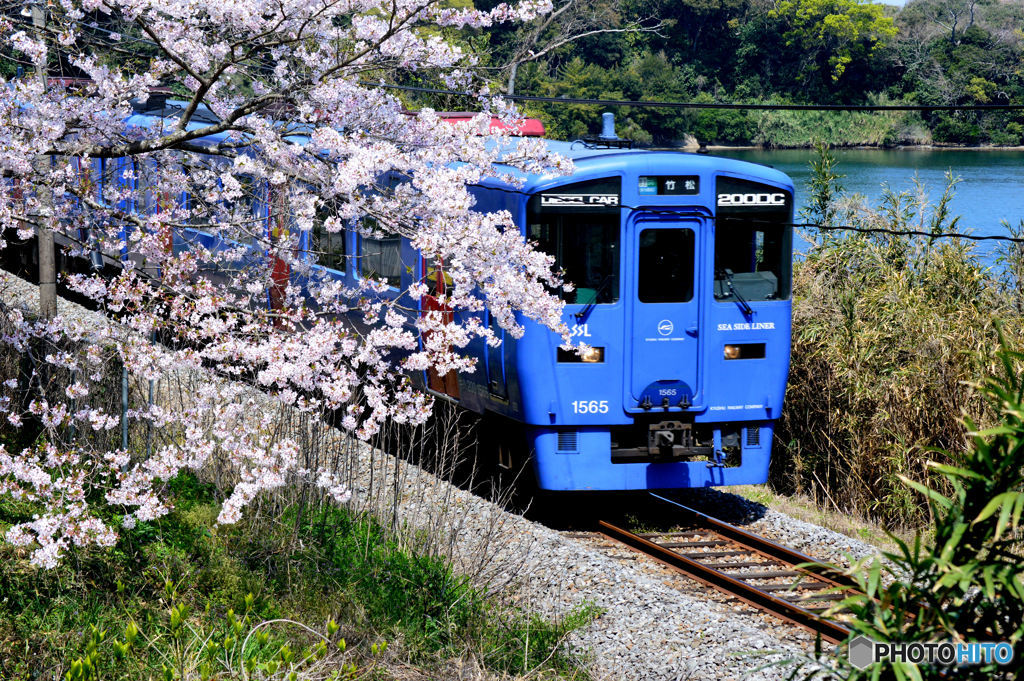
475, 0, 1024, 146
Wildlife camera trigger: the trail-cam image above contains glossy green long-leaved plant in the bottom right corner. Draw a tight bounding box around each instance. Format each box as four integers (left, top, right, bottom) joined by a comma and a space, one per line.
844, 339, 1024, 681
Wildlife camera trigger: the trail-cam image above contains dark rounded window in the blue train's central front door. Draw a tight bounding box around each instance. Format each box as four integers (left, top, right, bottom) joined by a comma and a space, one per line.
637, 228, 694, 303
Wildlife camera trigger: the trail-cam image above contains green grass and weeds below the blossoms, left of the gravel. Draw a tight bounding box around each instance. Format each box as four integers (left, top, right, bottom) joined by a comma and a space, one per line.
0, 474, 596, 681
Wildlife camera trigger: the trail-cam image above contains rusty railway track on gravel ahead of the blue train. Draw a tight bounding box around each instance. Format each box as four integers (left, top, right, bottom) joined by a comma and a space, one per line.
598, 495, 856, 643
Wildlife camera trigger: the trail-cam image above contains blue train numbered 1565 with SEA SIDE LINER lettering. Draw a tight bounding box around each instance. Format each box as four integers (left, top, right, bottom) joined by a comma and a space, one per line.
37, 100, 794, 492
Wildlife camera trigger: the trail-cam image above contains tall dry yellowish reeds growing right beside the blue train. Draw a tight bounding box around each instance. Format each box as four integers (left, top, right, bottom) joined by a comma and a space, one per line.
772, 144, 1024, 524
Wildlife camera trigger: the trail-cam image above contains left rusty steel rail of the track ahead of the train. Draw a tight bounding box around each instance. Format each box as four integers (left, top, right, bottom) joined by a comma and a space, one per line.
598, 520, 850, 643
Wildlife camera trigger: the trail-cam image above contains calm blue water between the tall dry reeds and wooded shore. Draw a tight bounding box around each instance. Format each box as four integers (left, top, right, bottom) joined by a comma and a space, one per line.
715, 150, 1024, 254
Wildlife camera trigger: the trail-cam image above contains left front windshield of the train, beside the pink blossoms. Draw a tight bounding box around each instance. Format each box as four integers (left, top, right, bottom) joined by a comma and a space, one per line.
526, 179, 622, 305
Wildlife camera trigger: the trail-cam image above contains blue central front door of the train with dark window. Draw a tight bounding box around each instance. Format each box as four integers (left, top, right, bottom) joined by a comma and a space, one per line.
626, 212, 703, 403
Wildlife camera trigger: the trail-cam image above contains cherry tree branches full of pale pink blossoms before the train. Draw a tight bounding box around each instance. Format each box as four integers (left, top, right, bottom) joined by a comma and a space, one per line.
0, 0, 569, 566
